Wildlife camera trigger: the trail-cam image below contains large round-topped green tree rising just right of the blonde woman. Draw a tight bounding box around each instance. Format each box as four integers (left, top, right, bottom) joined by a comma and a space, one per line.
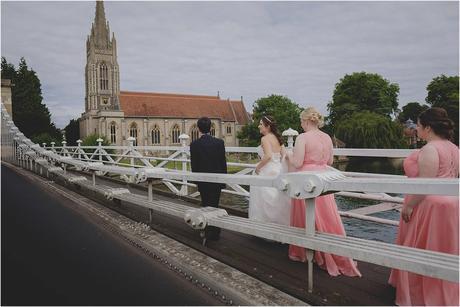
328, 72, 399, 126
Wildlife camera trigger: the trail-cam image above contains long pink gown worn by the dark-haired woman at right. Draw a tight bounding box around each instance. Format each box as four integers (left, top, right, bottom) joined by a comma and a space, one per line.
388, 140, 459, 306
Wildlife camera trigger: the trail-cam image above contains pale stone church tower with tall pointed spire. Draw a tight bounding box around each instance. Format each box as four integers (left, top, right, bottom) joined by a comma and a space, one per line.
85, 0, 120, 114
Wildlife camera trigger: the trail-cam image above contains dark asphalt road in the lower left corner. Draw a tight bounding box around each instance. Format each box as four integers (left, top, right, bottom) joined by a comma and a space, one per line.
1, 165, 221, 305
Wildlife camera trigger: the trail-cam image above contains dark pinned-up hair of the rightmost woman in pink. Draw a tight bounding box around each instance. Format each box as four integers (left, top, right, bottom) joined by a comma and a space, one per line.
418, 107, 454, 140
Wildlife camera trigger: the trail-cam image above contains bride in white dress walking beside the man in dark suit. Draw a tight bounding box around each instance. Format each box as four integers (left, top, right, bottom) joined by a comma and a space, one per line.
249, 116, 291, 225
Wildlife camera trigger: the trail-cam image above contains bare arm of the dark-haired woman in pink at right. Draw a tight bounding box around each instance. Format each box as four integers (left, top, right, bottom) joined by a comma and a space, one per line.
401, 144, 439, 222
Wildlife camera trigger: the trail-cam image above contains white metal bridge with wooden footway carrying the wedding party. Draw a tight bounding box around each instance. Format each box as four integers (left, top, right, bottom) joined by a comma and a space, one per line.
2, 102, 459, 305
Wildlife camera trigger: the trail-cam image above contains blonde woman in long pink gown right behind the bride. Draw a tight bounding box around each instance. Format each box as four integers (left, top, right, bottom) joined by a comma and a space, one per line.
286, 107, 361, 276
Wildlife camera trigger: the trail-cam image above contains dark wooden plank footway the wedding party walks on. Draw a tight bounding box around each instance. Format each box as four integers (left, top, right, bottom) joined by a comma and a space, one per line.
74, 173, 395, 305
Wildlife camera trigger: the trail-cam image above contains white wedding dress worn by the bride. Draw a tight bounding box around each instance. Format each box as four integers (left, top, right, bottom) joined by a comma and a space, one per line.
248, 146, 291, 225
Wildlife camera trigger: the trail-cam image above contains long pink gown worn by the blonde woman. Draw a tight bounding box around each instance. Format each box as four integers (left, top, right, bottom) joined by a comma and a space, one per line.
289, 130, 361, 276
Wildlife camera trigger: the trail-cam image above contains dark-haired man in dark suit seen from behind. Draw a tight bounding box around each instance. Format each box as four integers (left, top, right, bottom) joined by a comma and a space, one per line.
190, 117, 227, 240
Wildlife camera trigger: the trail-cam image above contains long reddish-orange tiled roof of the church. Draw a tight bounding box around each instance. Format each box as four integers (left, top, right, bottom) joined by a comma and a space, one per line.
120, 91, 249, 125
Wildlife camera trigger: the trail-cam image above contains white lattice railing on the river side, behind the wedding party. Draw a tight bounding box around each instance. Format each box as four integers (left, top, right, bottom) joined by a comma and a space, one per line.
38, 134, 412, 226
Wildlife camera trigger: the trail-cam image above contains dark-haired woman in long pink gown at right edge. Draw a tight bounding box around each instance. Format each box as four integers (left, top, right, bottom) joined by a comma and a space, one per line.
389, 108, 459, 306
